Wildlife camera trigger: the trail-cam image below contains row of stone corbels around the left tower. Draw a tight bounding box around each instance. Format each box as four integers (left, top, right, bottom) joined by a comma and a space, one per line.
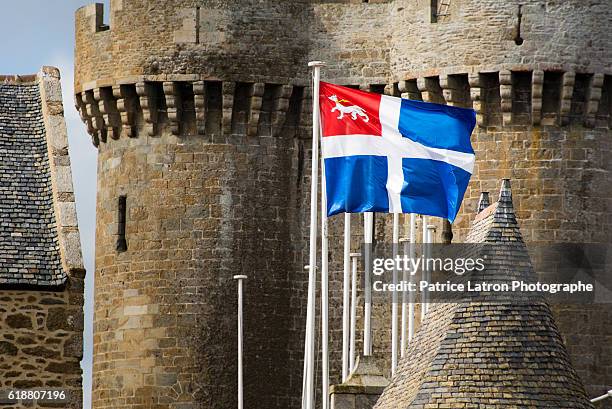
78, 81, 310, 142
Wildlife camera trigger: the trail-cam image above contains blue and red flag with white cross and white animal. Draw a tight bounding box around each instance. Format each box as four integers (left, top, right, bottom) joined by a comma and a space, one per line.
319, 82, 476, 222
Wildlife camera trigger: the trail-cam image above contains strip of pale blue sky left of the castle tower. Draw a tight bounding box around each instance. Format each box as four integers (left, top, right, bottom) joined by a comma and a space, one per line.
0, 0, 109, 409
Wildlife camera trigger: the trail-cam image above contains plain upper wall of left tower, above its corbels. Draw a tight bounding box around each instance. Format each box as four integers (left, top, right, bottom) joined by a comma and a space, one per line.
75, 0, 306, 91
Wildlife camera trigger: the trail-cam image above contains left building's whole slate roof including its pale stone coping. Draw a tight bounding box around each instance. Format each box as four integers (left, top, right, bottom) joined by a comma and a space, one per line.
0, 66, 84, 288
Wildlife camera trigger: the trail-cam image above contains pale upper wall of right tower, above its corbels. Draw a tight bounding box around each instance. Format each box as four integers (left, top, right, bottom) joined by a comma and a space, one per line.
390, 0, 612, 80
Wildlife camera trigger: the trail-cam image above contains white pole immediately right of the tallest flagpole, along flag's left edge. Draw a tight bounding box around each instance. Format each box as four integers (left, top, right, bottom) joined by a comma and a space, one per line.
321, 146, 329, 409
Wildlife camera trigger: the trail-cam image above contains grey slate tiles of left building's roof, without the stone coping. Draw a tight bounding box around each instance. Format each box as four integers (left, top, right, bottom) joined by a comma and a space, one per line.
0, 80, 66, 287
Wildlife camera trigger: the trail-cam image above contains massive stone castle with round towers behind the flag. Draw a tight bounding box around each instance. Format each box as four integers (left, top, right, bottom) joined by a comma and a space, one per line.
75, 0, 612, 409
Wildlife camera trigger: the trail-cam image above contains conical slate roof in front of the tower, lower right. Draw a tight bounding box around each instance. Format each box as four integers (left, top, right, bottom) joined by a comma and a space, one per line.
375, 180, 593, 409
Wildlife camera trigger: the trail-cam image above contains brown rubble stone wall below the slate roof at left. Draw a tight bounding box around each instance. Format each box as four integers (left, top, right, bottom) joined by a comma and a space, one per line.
0, 286, 83, 409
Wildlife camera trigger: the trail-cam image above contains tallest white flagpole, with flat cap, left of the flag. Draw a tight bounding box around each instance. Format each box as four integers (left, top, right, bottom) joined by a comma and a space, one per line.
302, 61, 325, 409
